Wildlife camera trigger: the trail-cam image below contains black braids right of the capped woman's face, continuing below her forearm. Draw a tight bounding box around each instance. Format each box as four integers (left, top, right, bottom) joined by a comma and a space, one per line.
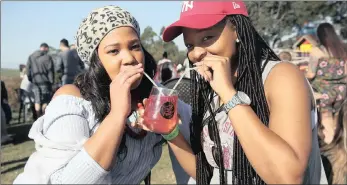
230, 15, 279, 184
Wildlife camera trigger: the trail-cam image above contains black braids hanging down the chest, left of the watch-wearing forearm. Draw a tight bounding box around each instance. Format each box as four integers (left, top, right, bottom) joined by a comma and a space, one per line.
190, 53, 227, 184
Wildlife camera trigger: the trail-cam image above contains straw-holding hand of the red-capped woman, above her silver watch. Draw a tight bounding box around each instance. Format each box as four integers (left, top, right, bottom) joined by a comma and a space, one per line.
194, 55, 236, 102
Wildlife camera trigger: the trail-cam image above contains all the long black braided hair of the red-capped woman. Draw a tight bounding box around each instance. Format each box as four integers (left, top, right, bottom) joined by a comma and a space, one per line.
190, 15, 280, 184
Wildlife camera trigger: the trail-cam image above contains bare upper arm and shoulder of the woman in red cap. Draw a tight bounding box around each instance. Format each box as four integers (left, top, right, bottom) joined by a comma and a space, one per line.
265, 62, 312, 173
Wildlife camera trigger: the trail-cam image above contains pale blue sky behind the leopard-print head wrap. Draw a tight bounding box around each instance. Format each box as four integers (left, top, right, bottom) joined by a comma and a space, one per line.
1, 1, 185, 68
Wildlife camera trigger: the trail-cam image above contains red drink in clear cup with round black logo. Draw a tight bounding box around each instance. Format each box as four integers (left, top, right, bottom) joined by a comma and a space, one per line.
144, 95, 178, 134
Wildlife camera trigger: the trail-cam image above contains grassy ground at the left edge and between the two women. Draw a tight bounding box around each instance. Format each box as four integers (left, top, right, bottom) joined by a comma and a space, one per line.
0, 69, 176, 184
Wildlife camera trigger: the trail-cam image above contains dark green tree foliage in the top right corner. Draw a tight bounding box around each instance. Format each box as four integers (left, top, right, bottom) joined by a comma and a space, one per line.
246, 1, 347, 47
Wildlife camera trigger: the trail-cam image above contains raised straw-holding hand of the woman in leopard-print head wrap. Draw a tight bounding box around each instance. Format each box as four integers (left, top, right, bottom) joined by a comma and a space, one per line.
110, 64, 143, 119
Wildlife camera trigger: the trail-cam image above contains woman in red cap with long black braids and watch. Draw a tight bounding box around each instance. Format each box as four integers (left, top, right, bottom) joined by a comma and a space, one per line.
163, 1, 322, 184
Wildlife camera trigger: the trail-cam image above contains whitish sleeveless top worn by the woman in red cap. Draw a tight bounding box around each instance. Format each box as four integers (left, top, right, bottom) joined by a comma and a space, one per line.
196, 61, 321, 184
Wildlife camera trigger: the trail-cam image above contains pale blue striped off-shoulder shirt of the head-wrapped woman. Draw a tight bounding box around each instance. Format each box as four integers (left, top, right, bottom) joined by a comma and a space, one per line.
14, 95, 191, 184
